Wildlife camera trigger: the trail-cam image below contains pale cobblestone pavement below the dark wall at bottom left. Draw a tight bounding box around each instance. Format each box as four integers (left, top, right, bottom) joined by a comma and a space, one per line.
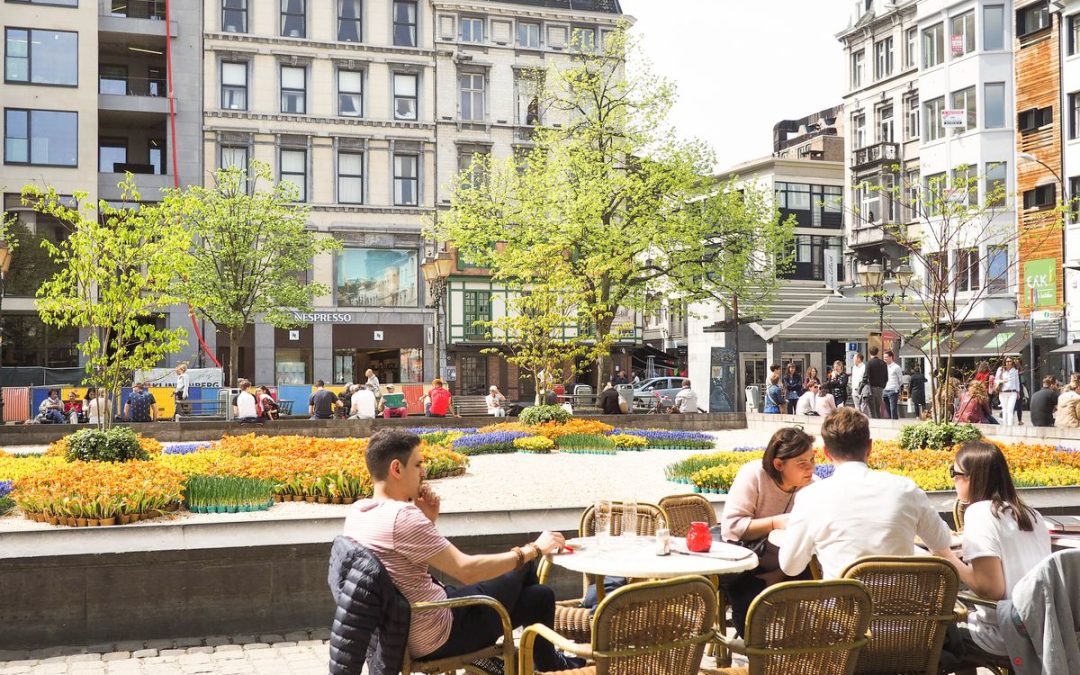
0, 630, 329, 675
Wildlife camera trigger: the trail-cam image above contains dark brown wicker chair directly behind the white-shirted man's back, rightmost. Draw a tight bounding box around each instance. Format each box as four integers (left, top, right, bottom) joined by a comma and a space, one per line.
843, 555, 960, 675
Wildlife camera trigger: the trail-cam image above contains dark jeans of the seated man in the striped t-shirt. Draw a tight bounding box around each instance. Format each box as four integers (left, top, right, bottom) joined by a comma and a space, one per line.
423, 561, 565, 671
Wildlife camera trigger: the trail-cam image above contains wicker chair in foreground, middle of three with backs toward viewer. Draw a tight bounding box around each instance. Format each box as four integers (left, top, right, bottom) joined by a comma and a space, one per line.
702, 579, 873, 675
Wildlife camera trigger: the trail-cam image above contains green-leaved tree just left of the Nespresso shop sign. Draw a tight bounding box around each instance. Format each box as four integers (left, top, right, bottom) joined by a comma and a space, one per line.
160, 162, 340, 387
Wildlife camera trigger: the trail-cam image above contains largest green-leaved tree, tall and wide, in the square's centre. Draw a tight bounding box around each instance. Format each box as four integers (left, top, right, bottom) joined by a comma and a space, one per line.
430, 29, 793, 386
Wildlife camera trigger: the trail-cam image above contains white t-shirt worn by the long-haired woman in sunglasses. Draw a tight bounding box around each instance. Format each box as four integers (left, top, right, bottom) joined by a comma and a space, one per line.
963, 501, 1050, 656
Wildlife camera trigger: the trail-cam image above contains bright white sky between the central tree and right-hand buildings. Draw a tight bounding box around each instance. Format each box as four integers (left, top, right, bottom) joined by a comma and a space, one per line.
620, 0, 854, 170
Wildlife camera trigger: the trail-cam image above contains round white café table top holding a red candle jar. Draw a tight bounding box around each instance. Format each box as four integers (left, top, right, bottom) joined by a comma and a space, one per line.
551, 537, 757, 579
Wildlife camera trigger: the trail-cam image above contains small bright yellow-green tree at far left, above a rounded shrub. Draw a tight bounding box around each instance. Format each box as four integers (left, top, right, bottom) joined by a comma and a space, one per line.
23, 174, 191, 427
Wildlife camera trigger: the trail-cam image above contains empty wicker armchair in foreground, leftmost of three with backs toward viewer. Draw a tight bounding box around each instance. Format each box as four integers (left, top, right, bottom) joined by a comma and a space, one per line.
518, 577, 716, 675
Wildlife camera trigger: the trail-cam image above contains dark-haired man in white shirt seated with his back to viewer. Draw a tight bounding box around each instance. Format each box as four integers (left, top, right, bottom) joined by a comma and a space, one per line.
780, 407, 950, 579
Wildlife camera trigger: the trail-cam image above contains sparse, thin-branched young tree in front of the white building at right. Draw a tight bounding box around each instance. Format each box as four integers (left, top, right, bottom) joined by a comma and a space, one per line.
853, 165, 1065, 421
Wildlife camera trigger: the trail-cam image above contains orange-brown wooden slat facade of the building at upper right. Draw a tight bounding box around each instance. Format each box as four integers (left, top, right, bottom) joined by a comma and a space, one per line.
1013, 1, 1065, 316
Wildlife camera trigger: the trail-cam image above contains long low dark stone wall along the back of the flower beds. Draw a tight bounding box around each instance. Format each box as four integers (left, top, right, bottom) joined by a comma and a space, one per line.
0, 413, 746, 447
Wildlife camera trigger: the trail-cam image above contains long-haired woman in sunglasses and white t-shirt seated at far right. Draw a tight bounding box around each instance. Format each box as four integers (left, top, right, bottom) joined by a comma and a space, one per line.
942, 441, 1050, 673
